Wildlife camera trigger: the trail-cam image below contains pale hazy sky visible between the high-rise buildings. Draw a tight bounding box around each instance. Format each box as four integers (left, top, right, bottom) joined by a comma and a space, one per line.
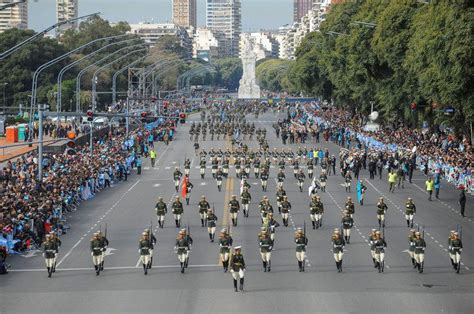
28, 0, 293, 31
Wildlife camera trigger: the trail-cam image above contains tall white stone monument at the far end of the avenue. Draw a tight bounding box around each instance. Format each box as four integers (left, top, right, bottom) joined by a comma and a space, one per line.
239, 34, 260, 99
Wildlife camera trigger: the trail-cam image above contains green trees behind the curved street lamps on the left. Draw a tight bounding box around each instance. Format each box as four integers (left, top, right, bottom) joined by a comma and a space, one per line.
0, 17, 242, 110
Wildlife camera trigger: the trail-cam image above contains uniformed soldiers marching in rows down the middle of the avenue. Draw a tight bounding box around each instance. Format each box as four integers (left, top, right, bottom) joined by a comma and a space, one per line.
44, 105, 462, 291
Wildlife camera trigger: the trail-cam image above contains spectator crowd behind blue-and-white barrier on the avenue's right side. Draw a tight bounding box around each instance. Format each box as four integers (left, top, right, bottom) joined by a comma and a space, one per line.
289, 103, 474, 193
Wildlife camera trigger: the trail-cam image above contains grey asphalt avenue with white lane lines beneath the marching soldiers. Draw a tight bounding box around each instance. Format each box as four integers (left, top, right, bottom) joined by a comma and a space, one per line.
0, 113, 474, 313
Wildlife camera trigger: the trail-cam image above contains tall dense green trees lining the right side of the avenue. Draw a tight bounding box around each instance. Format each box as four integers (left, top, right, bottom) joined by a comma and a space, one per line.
257, 0, 474, 134
